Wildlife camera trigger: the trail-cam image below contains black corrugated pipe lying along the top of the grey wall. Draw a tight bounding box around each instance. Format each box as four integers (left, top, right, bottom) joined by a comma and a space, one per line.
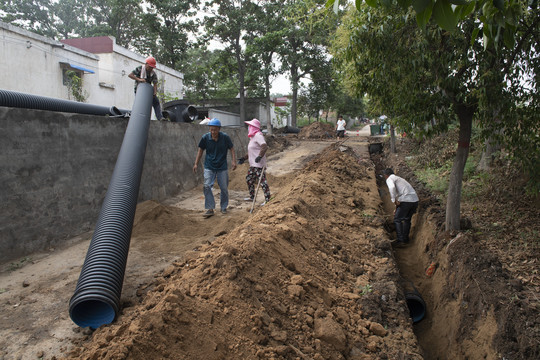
0, 89, 129, 117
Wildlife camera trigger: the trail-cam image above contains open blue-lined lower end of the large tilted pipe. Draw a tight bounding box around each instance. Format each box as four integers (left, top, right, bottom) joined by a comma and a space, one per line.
69, 288, 119, 329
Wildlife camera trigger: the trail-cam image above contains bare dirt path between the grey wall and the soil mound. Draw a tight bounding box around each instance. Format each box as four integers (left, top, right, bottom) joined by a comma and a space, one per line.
0, 136, 360, 359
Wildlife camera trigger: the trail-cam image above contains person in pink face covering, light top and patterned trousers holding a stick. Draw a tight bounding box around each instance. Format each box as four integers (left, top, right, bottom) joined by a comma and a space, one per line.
240, 119, 270, 205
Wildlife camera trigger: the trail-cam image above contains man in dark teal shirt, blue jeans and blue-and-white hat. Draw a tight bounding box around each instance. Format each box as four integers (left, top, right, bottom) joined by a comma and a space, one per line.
193, 118, 236, 218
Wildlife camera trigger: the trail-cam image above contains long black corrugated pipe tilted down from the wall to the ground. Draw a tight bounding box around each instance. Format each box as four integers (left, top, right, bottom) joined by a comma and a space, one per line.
69, 83, 154, 329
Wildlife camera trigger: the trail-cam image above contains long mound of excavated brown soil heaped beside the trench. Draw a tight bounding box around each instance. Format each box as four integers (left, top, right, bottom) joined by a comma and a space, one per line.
65, 146, 421, 359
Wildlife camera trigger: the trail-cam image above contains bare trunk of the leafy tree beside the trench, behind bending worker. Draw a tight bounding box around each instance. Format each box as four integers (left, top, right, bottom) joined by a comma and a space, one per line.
445, 105, 475, 231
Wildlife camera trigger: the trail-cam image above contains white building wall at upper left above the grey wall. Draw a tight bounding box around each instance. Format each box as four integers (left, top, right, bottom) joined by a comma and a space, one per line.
0, 21, 184, 118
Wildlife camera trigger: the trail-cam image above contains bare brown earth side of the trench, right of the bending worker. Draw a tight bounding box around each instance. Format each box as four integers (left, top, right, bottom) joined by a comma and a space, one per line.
372, 147, 540, 360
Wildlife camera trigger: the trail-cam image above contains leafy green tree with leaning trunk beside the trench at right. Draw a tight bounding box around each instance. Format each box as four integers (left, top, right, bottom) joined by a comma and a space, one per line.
333, 1, 540, 229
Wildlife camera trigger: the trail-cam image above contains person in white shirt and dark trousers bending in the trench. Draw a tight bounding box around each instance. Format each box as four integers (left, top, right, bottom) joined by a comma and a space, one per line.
383, 168, 418, 245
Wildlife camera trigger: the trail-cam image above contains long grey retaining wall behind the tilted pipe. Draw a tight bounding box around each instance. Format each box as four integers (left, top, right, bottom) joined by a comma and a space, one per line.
0, 107, 249, 263
